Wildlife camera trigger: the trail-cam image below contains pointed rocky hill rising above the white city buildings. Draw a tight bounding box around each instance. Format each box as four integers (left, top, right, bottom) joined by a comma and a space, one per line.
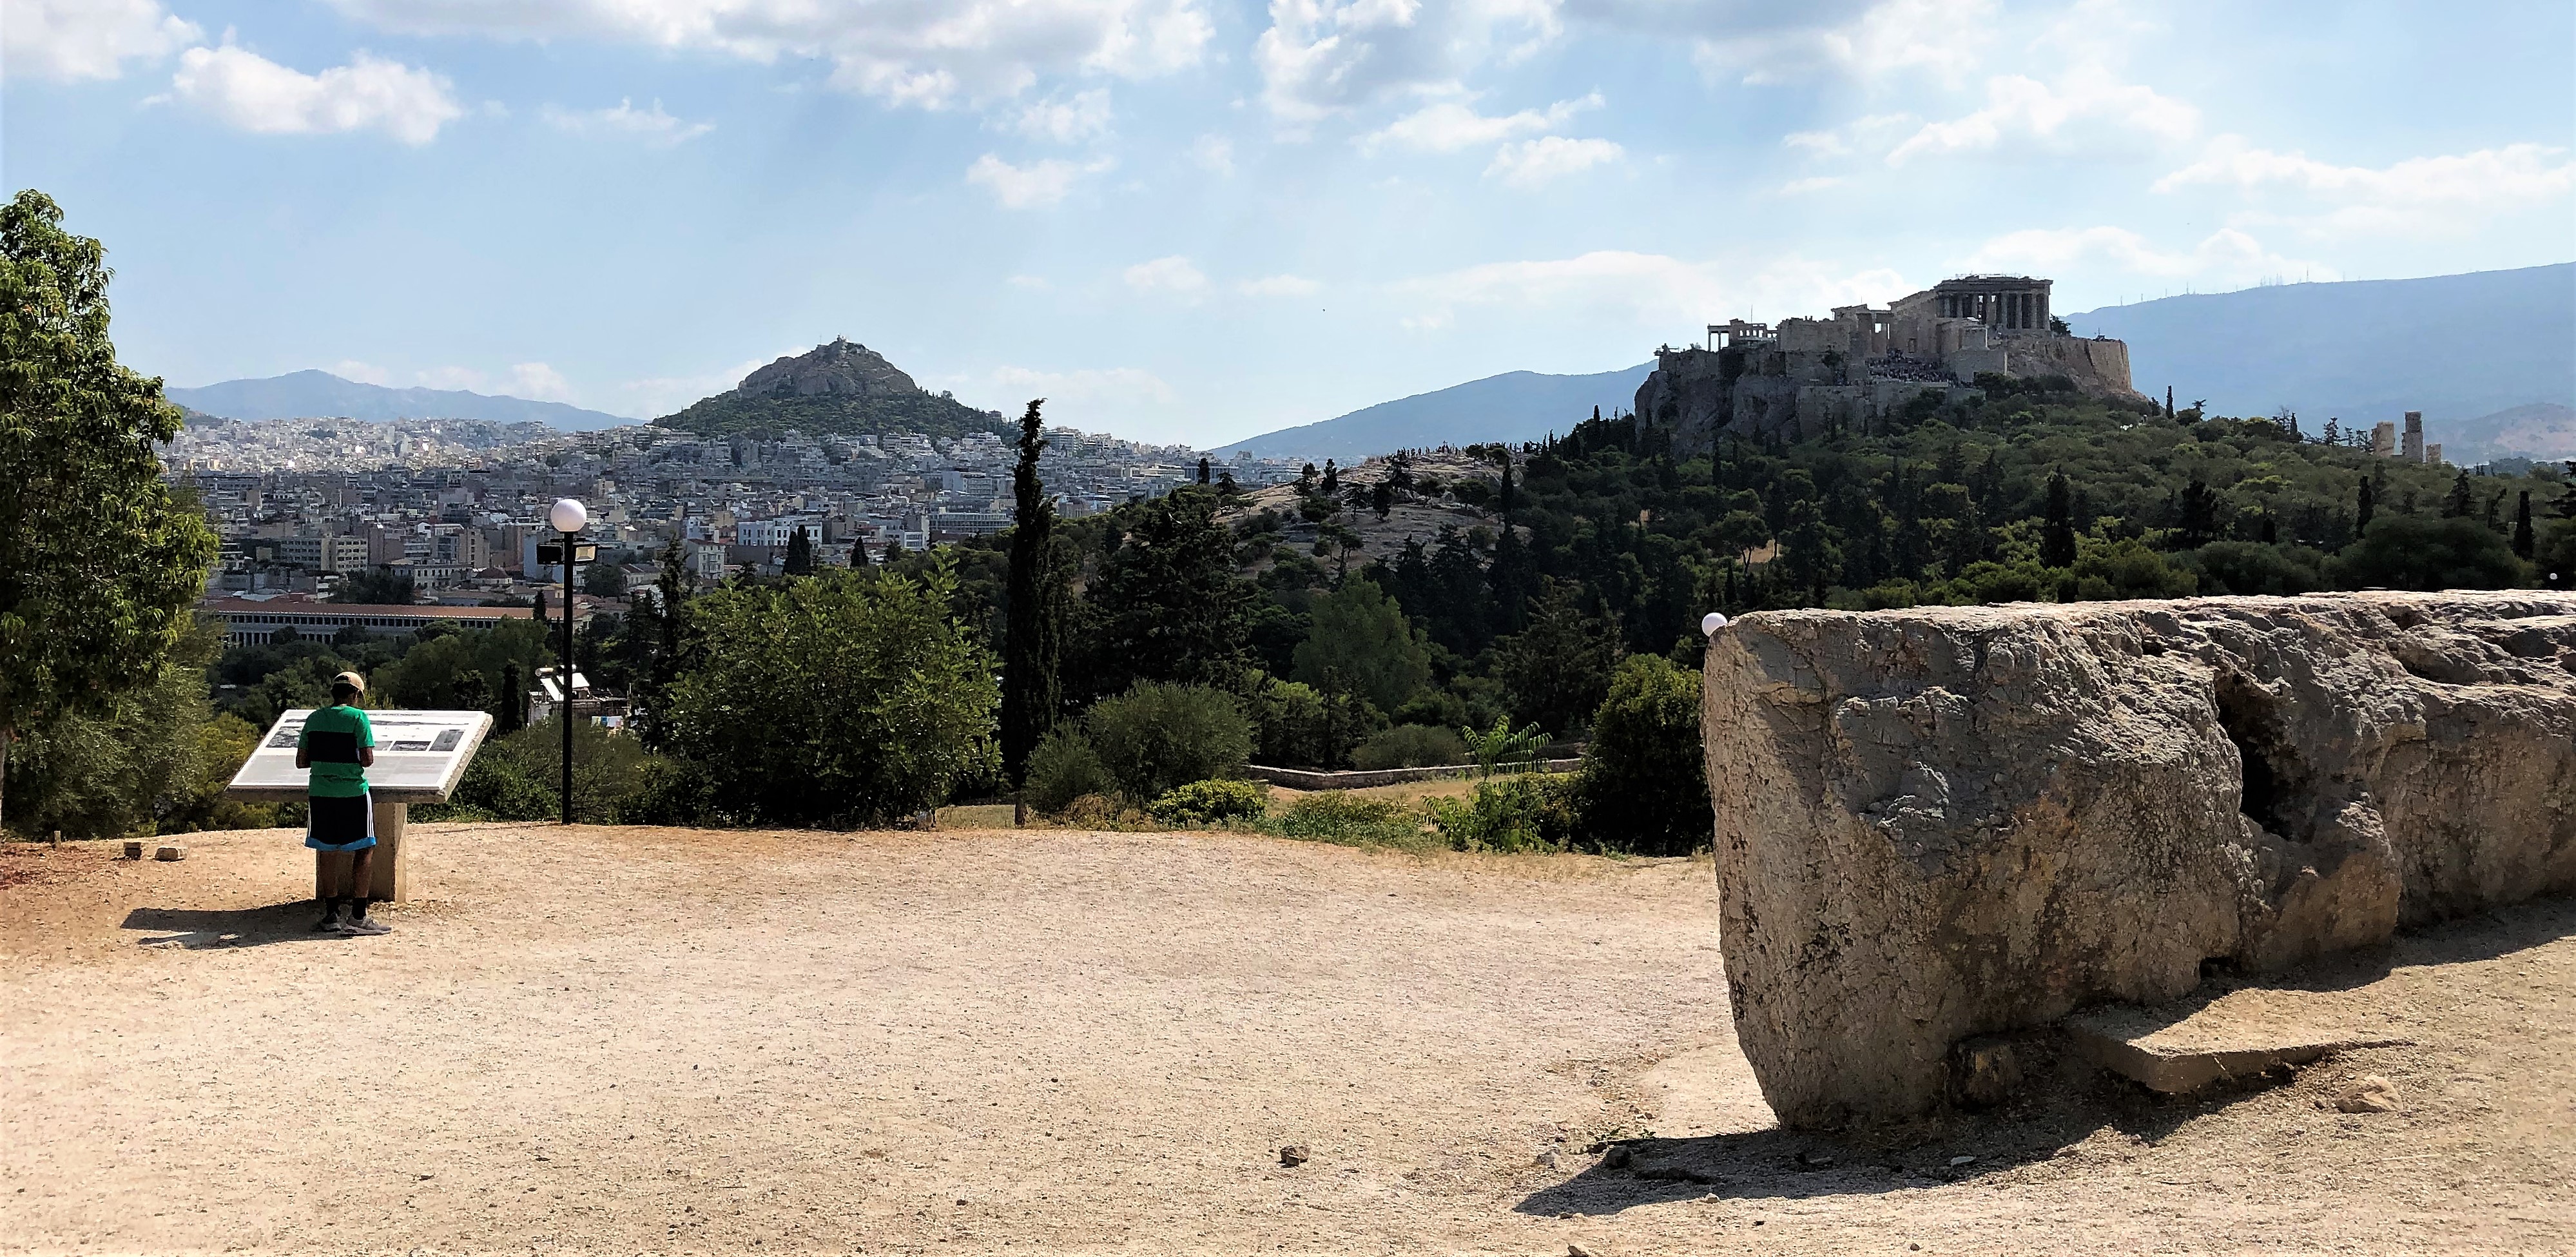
654, 337, 1010, 435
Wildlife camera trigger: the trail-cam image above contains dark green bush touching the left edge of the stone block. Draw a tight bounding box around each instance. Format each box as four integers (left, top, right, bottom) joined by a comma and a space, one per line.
1574, 654, 1716, 855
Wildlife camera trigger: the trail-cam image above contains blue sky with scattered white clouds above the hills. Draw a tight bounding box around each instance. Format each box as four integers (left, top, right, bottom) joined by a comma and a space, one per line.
0, 0, 2576, 448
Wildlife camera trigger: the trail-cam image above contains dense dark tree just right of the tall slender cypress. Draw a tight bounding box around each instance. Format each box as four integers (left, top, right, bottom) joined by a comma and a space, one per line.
1085, 487, 1255, 693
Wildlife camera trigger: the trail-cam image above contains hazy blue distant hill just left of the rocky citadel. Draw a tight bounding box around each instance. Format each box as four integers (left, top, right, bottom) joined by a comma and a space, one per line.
1211, 363, 1654, 463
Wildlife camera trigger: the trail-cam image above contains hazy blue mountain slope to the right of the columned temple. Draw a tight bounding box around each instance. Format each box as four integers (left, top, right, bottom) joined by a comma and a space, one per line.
2066, 263, 2576, 463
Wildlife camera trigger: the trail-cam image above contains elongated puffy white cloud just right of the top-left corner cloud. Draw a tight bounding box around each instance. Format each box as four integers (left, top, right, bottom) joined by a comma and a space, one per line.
170, 44, 463, 144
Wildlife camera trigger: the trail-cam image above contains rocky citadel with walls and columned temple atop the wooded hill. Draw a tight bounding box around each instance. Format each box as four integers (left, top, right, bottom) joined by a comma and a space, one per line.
1636, 276, 2141, 451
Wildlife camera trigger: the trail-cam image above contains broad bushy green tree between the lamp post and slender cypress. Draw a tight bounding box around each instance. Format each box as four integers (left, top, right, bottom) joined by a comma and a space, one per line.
667, 567, 1002, 827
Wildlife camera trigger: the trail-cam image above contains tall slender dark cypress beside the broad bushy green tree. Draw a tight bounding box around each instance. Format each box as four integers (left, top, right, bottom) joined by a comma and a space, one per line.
1002, 396, 1061, 786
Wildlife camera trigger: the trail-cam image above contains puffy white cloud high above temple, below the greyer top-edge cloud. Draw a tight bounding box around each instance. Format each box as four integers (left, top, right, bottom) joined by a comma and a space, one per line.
1888, 72, 2200, 165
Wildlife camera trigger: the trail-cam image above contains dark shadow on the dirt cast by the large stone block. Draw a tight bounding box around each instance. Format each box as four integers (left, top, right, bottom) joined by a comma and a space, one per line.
1515, 899, 2576, 1216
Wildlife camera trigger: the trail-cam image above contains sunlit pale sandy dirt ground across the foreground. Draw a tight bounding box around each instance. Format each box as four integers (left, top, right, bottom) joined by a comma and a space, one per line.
0, 824, 2576, 1254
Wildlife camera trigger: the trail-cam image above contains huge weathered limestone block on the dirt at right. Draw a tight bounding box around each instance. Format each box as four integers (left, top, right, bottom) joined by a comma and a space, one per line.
1703, 592, 2576, 1125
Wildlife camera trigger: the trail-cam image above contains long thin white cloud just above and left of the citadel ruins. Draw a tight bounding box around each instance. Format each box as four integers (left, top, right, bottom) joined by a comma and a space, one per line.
1388, 250, 1912, 335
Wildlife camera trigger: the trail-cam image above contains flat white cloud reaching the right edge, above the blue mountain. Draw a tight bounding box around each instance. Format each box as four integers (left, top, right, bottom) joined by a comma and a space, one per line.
2156, 137, 2576, 235
